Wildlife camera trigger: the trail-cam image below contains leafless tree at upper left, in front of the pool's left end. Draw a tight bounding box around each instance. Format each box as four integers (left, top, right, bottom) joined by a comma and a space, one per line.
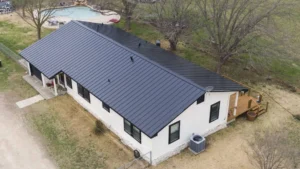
13, 0, 59, 39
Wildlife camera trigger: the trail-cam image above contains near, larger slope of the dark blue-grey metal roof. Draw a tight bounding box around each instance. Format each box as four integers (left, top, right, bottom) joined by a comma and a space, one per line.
21, 21, 205, 138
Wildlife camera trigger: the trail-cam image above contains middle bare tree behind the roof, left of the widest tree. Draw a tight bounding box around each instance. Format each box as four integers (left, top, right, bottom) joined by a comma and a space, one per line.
150, 0, 193, 51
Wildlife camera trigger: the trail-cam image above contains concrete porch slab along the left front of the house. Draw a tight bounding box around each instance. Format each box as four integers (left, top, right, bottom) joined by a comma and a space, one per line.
23, 75, 55, 100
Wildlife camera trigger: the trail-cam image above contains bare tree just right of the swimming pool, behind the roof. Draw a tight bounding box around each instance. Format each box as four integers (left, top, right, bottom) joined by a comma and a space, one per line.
92, 0, 139, 30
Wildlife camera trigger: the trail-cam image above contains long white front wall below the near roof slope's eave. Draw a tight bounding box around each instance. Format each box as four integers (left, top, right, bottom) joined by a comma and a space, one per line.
65, 77, 152, 161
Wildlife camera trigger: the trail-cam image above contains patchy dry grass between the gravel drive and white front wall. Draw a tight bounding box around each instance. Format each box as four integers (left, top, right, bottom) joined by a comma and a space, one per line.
27, 95, 137, 168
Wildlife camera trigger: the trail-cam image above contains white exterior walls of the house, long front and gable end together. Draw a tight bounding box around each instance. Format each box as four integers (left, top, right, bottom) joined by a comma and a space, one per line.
59, 74, 234, 165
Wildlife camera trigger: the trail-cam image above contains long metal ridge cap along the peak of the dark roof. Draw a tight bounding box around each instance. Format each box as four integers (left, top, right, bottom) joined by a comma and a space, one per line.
71, 21, 206, 91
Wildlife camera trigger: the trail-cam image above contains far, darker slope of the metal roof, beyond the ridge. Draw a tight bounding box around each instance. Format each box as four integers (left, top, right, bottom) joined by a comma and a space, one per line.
80, 21, 247, 91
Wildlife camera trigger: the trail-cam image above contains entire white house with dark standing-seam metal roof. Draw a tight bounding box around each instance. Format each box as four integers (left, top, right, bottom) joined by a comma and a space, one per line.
21, 21, 247, 165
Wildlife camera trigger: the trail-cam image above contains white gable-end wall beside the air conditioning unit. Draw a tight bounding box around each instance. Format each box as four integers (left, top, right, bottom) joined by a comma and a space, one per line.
152, 92, 234, 164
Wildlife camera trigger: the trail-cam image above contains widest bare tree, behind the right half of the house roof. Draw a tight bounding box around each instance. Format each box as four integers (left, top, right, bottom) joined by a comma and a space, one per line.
196, 0, 286, 73
